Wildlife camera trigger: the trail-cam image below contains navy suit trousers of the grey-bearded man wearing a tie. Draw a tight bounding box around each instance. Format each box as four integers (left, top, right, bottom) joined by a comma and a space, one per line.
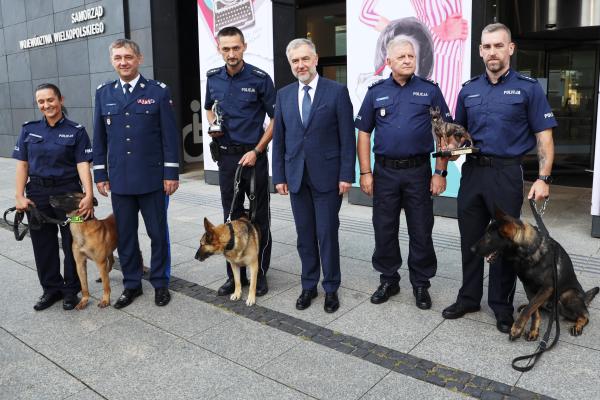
290, 168, 342, 293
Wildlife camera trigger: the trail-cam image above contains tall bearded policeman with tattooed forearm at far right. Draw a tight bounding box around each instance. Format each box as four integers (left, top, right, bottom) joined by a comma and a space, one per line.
442, 23, 556, 333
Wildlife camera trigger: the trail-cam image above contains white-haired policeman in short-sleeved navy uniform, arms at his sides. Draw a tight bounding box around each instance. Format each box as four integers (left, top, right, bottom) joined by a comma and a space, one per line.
355, 37, 450, 309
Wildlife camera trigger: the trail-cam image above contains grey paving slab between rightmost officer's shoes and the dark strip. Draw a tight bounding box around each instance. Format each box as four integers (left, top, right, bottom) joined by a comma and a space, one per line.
410, 318, 533, 385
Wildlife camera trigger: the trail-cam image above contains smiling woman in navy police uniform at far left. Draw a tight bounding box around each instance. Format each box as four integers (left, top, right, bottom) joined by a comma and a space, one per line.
13, 83, 94, 311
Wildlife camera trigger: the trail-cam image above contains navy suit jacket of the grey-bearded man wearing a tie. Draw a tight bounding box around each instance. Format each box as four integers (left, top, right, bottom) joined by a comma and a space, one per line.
273, 77, 356, 193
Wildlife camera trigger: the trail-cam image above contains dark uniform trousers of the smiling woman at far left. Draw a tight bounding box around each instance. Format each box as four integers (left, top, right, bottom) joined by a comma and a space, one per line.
26, 181, 81, 295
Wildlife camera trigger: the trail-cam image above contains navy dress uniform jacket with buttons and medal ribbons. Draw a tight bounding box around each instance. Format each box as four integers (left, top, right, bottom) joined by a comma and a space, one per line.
93, 76, 180, 194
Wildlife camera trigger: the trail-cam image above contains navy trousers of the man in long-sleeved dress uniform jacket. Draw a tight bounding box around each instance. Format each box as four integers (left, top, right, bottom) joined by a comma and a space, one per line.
111, 189, 171, 289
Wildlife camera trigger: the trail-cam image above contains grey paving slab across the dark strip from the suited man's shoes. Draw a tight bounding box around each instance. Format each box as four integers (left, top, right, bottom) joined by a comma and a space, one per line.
258, 342, 388, 400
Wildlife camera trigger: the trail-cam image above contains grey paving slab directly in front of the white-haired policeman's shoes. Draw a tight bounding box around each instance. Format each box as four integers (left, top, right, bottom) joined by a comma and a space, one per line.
327, 301, 443, 353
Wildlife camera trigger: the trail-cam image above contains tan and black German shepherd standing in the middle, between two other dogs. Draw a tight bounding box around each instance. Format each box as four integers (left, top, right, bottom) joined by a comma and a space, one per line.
196, 217, 259, 306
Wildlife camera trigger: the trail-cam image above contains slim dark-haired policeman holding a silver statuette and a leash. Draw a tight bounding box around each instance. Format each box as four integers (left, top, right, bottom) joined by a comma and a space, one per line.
204, 27, 275, 296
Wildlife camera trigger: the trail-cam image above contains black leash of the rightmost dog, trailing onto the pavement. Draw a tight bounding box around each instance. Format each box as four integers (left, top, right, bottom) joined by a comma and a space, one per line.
512, 198, 560, 372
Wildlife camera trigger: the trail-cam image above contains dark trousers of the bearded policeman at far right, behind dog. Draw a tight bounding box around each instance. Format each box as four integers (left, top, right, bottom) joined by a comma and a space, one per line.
457, 160, 523, 315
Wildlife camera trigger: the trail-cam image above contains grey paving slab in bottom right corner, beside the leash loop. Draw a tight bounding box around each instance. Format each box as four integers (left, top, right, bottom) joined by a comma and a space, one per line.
518, 343, 600, 400
